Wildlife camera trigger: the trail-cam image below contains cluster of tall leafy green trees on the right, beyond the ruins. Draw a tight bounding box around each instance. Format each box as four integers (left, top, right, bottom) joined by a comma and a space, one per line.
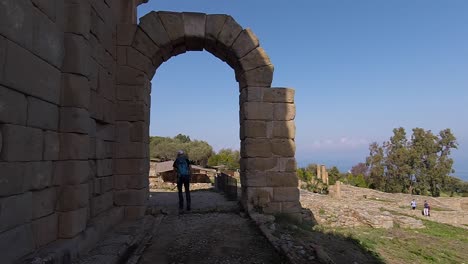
365, 127, 458, 196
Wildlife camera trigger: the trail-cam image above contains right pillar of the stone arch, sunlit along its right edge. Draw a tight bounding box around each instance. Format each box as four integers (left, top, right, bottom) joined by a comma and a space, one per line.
240, 87, 301, 217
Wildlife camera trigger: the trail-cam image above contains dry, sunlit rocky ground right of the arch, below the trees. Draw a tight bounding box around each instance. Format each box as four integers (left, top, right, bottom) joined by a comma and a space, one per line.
301, 185, 468, 229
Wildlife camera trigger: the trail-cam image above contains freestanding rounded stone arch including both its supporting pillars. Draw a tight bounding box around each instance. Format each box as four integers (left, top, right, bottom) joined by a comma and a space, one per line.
114, 11, 301, 215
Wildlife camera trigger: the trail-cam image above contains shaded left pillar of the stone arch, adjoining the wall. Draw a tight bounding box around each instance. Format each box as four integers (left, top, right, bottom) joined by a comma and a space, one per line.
114, 20, 151, 219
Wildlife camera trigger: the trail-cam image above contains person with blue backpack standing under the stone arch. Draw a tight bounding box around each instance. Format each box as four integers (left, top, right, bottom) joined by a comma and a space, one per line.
172, 150, 191, 211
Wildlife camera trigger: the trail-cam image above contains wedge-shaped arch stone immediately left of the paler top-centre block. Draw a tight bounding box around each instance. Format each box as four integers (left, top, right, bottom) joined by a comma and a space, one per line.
158, 11, 186, 51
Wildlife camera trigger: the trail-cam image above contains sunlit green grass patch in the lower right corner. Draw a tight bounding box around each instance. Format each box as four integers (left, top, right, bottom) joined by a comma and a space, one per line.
323, 221, 468, 263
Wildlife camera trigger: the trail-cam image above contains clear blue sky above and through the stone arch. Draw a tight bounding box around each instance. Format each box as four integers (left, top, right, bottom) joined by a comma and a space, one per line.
138, 0, 468, 180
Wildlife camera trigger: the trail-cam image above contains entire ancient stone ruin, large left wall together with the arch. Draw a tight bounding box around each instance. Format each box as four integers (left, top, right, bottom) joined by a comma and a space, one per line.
0, 0, 300, 263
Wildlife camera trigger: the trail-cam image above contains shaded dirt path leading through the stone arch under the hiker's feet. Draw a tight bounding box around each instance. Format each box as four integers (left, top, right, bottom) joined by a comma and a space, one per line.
139, 190, 285, 264
